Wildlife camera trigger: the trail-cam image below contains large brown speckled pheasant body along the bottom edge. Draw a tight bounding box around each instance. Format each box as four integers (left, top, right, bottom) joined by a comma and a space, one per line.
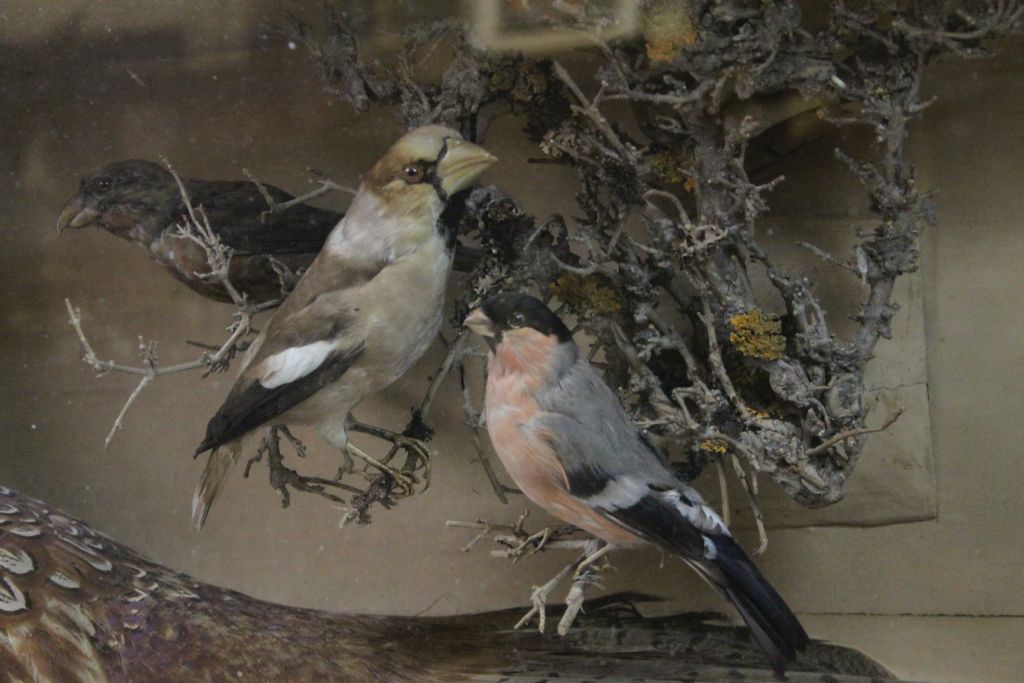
0, 486, 890, 683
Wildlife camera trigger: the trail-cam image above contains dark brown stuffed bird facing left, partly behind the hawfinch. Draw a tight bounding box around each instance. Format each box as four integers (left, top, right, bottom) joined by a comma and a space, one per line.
57, 159, 342, 302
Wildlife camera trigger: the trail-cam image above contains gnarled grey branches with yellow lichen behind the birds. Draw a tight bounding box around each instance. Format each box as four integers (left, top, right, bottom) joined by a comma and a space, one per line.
285, 0, 1024, 529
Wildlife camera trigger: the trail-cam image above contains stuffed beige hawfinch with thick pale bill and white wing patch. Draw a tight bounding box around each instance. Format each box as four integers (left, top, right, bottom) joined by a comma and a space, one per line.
193, 126, 497, 526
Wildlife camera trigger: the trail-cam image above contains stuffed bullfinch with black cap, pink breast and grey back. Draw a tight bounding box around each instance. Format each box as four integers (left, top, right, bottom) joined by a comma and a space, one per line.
465, 293, 808, 675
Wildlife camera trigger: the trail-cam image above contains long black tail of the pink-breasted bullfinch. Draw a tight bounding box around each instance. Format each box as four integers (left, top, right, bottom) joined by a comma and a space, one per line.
693, 536, 809, 676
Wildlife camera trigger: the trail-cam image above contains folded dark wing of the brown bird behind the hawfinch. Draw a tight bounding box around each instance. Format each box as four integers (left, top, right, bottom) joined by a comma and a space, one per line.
186, 180, 342, 256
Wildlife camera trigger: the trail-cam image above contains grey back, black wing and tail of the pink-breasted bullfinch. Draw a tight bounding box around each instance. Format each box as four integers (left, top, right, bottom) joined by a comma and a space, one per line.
540, 360, 808, 674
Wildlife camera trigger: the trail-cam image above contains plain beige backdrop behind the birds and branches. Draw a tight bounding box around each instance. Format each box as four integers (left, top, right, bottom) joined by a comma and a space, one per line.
0, 0, 1024, 681
